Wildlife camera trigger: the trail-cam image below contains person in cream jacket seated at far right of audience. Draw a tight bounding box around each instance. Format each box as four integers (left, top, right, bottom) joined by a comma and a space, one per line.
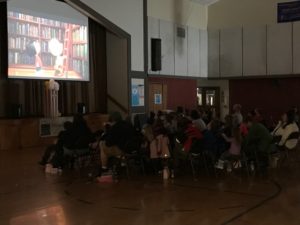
272, 110, 299, 150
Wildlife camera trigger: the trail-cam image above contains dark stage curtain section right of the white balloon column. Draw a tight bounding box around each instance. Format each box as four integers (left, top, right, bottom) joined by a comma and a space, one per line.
59, 19, 107, 114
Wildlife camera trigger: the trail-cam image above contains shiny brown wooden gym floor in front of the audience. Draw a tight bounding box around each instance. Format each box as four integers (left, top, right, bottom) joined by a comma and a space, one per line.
0, 149, 300, 225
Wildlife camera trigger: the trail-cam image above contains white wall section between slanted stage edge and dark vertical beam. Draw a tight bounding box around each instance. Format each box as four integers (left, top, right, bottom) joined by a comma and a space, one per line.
81, 0, 144, 71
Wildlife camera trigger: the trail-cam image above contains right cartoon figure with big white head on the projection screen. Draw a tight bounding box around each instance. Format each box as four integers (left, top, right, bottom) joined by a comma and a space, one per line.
49, 38, 66, 77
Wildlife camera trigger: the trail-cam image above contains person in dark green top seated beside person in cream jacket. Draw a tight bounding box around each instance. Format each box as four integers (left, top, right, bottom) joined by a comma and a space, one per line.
242, 112, 272, 168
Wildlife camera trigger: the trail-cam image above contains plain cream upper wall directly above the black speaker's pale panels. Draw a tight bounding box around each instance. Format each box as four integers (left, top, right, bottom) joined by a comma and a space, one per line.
148, 0, 207, 29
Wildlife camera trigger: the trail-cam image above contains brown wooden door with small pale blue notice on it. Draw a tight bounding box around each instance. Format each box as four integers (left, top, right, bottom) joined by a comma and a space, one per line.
149, 83, 168, 113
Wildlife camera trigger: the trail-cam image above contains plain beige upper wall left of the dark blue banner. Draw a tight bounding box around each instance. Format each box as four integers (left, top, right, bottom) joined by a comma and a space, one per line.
208, 0, 291, 29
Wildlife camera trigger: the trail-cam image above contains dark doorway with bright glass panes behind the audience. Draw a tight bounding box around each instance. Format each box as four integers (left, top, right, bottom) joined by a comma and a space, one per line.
197, 87, 220, 117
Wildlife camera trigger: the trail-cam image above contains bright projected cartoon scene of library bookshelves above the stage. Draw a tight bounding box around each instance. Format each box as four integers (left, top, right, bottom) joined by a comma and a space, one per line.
8, 11, 89, 81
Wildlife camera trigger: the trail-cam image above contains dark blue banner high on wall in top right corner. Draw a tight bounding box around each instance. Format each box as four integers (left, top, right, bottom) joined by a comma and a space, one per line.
277, 1, 300, 23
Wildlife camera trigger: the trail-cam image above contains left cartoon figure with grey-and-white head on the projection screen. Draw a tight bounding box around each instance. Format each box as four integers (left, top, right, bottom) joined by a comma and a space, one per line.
26, 41, 43, 76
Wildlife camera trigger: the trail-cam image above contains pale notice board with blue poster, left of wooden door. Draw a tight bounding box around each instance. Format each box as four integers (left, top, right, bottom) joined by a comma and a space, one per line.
131, 78, 145, 107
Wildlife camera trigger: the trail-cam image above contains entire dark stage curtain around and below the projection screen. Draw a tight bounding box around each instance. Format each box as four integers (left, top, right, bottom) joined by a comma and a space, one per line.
0, 2, 107, 117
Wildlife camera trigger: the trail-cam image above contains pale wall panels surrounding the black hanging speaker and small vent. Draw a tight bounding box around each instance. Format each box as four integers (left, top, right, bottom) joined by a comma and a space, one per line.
148, 17, 207, 77
